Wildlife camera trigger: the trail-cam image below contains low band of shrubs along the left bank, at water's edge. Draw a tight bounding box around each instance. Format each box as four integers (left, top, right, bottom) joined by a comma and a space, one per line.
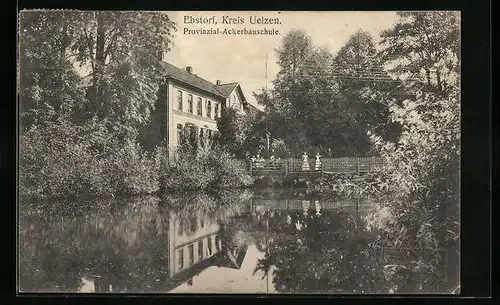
20, 121, 253, 199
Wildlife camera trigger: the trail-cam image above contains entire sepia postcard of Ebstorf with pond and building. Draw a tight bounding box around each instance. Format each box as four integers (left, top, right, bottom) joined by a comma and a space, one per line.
17, 10, 461, 295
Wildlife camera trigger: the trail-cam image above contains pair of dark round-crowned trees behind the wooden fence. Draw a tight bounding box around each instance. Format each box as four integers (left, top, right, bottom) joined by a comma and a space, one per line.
255, 30, 404, 157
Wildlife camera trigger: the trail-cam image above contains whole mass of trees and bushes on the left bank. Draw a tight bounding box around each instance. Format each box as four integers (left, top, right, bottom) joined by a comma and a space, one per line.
19, 11, 251, 198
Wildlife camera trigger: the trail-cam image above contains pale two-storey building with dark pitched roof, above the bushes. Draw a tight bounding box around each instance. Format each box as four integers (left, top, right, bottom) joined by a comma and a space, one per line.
81, 61, 260, 151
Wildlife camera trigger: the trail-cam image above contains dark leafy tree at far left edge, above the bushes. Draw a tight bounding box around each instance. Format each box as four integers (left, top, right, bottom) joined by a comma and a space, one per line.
19, 11, 84, 127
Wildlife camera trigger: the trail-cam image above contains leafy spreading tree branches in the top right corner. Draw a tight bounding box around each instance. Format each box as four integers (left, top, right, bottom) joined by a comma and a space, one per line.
381, 11, 460, 91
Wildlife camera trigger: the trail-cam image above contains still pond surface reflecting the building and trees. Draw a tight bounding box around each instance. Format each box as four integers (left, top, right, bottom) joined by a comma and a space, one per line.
19, 192, 458, 294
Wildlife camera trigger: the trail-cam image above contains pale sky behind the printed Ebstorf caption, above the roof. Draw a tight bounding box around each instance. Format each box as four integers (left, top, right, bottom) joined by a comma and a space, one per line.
164, 11, 396, 108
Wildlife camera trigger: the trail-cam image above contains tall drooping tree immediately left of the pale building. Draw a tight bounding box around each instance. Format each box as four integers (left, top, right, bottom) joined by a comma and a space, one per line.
73, 11, 175, 127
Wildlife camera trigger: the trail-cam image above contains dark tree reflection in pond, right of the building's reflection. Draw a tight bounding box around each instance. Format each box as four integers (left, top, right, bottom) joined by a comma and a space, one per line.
237, 198, 458, 294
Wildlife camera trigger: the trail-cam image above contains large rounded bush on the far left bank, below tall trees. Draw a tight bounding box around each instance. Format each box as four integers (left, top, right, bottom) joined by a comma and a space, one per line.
20, 122, 159, 198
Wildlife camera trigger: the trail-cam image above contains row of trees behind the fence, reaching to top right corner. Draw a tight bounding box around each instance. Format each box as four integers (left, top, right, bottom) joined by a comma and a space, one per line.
237, 13, 458, 157
